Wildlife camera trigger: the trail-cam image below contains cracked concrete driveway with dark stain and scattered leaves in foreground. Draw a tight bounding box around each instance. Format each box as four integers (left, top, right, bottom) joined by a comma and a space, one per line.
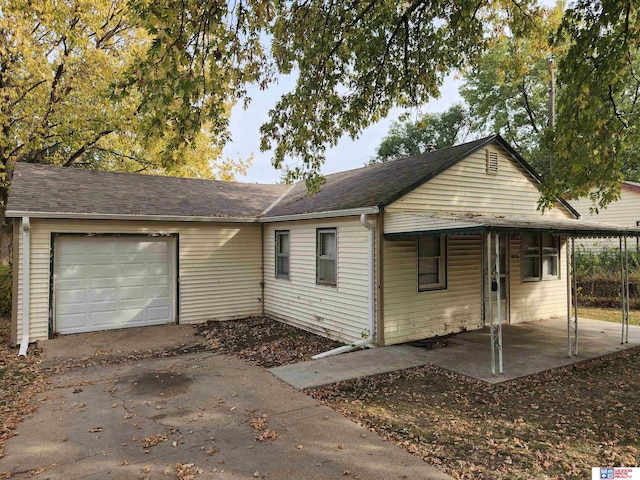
0, 330, 450, 480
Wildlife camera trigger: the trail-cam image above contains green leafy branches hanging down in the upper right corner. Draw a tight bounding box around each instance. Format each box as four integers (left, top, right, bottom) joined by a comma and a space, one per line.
544, 0, 640, 210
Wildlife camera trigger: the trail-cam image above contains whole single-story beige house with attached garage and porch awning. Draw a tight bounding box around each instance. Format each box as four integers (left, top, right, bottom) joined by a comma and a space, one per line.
6, 135, 640, 372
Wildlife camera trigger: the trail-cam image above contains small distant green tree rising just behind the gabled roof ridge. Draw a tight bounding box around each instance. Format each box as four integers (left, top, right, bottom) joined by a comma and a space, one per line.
370, 104, 473, 164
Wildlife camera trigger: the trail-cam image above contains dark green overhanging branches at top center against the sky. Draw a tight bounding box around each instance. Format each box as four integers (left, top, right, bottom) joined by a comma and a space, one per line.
261, 0, 538, 188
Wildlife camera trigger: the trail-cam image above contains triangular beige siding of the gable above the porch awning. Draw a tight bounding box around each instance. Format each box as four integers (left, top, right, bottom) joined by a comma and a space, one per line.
386, 145, 572, 218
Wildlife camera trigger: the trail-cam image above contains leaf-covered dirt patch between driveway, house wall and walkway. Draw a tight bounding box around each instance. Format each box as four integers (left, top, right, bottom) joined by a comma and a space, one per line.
196, 317, 342, 368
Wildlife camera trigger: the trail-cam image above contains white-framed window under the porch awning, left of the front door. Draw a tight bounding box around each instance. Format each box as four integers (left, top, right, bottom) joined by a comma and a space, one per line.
417, 235, 447, 292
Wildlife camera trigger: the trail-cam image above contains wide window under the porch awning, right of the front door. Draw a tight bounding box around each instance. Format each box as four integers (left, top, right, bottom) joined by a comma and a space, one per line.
521, 233, 560, 282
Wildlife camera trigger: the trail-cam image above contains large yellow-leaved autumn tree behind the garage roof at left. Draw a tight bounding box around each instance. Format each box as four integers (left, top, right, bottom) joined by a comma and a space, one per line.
0, 0, 246, 213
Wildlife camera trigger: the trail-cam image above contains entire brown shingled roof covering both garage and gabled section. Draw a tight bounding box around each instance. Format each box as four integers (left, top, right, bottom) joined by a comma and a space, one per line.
7, 135, 577, 219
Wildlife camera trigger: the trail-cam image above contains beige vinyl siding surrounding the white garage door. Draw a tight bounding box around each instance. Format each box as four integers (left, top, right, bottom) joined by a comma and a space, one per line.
17, 219, 262, 341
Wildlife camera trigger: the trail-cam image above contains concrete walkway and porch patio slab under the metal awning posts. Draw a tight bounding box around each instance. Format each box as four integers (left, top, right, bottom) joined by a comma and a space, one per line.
271, 318, 640, 389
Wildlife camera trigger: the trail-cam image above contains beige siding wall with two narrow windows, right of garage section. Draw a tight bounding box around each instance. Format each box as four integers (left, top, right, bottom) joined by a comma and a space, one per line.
264, 217, 374, 342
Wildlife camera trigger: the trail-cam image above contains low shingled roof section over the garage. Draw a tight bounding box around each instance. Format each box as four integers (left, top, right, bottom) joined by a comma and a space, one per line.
7, 163, 287, 217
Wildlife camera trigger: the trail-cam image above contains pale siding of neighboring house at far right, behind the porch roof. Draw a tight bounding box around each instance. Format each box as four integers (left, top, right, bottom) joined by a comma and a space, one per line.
570, 186, 640, 249
